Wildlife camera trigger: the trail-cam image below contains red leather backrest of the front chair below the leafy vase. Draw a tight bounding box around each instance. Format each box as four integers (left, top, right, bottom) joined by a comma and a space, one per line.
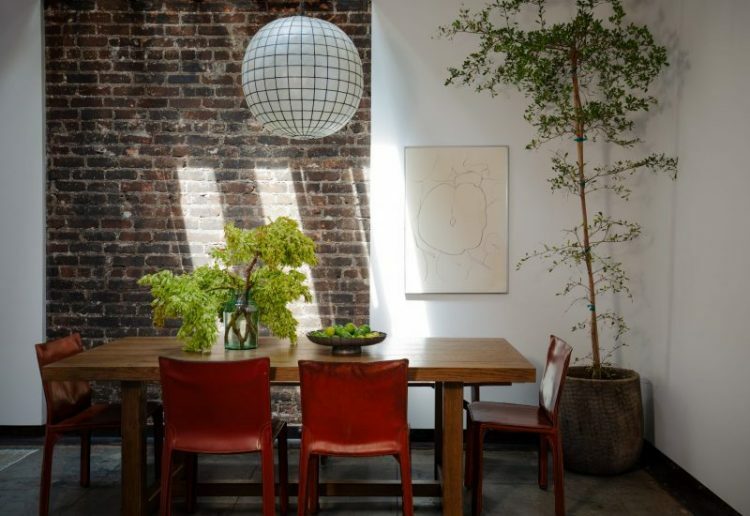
159, 357, 272, 453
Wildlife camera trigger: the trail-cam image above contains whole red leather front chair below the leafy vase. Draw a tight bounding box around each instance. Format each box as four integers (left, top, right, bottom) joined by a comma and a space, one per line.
159, 357, 288, 516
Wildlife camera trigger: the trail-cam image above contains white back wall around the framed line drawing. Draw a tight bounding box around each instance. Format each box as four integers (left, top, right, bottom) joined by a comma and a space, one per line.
370, 0, 656, 428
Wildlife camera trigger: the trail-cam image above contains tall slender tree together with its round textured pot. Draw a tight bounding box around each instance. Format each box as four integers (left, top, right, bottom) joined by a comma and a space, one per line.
440, 0, 677, 474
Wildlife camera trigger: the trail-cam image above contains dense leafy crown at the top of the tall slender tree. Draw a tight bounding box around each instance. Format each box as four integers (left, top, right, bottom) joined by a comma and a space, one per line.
438, 0, 667, 147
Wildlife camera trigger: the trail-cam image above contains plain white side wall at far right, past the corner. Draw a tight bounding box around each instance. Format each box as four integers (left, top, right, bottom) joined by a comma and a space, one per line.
642, 0, 750, 514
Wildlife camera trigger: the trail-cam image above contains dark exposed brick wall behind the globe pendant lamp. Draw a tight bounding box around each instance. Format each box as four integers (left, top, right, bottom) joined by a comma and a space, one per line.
45, 0, 370, 418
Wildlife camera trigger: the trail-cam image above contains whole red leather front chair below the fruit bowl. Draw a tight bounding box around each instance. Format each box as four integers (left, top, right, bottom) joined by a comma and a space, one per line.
297, 360, 414, 516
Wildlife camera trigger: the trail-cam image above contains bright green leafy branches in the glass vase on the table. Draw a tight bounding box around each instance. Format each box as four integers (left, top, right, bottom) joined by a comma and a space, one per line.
138, 217, 317, 351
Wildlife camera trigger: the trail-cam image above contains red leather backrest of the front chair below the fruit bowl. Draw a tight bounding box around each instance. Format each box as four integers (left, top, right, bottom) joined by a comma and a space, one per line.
299, 360, 409, 454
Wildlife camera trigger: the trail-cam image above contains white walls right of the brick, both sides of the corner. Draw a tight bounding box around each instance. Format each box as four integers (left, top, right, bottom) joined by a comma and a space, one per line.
370, 0, 750, 514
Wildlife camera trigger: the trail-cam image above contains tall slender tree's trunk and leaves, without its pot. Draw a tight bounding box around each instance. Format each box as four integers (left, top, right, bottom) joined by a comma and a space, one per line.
440, 0, 677, 378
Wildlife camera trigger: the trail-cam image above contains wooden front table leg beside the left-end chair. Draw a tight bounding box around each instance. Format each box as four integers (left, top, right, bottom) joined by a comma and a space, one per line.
121, 382, 147, 516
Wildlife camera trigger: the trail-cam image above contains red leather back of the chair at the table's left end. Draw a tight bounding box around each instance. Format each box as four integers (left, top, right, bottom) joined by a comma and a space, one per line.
34, 333, 91, 424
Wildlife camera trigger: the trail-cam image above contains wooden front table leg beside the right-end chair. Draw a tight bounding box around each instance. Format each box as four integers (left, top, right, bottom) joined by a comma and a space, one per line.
442, 382, 464, 516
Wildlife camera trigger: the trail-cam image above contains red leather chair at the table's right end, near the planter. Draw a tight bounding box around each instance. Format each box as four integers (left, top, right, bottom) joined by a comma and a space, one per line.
464, 335, 572, 516
